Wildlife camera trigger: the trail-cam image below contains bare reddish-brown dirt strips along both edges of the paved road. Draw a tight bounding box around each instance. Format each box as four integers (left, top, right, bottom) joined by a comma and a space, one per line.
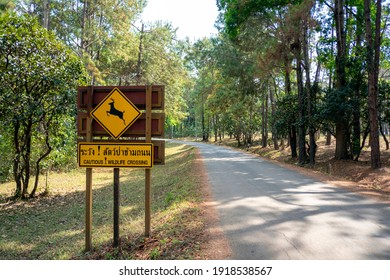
194, 140, 390, 259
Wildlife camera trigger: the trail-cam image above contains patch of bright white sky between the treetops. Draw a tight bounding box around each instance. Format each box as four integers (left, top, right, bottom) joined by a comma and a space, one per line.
141, 0, 218, 41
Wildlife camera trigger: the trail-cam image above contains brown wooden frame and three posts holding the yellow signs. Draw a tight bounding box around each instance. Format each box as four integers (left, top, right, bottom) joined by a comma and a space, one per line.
77, 86, 165, 251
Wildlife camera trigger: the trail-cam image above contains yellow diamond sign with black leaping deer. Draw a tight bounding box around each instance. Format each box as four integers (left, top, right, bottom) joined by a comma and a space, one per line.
91, 88, 141, 139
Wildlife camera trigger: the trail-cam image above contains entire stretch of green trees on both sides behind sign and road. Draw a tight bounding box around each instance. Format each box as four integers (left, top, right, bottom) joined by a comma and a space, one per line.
0, 0, 390, 198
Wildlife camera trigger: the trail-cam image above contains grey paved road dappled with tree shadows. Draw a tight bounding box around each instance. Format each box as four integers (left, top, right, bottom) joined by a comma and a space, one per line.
172, 143, 390, 260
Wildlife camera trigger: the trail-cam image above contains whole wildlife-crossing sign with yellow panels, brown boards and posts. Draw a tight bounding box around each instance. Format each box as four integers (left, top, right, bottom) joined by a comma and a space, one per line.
77, 86, 165, 251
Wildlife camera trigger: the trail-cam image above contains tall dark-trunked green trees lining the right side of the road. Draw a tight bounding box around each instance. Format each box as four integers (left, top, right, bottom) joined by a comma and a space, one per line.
187, 0, 389, 171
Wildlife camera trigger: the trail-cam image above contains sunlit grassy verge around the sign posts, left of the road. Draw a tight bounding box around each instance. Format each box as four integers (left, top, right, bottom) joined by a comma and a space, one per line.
0, 143, 205, 260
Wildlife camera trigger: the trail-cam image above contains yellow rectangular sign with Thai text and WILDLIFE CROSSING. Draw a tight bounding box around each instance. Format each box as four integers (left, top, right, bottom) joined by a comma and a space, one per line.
78, 142, 154, 168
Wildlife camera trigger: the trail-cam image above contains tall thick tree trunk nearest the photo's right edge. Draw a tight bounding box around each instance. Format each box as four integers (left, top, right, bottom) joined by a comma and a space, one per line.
364, 0, 382, 169
